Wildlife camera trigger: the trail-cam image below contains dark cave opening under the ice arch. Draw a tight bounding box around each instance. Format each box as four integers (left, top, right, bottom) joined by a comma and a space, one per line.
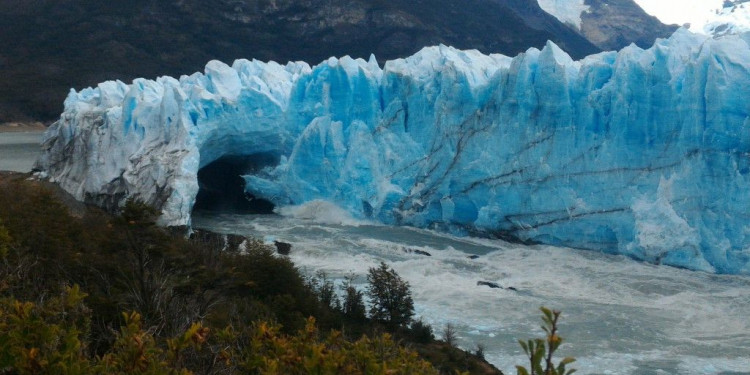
193, 153, 279, 214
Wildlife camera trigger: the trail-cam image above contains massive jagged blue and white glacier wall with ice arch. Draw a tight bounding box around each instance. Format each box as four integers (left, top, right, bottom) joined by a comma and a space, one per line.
37, 30, 750, 274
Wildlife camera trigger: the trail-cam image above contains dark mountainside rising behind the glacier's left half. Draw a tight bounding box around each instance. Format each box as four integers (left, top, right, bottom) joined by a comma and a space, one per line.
0, 0, 599, 123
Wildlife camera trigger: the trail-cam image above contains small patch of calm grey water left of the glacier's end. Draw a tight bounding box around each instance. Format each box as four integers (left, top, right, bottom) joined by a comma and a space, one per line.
0, 132, 42, 172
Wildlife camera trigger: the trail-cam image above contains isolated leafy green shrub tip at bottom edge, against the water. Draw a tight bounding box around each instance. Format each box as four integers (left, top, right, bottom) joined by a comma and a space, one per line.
516, 307, 576, 375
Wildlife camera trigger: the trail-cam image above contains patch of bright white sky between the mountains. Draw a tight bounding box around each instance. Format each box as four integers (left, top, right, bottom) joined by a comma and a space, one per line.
634, 0, 723, 25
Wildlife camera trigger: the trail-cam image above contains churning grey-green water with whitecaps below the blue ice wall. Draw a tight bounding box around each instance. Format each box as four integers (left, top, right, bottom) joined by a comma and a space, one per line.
193, 203, 750, 375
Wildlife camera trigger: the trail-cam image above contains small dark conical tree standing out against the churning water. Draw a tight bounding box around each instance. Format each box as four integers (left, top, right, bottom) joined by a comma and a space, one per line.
367, 262, 414, 327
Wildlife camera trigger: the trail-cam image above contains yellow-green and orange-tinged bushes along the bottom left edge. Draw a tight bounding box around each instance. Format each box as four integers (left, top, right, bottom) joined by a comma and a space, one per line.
0, 286, 438, 375
